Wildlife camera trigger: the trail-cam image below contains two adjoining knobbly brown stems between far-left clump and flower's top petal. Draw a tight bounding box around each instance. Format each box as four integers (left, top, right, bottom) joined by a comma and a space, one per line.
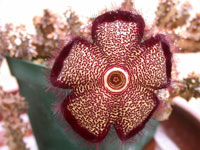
32, 8, 82, 58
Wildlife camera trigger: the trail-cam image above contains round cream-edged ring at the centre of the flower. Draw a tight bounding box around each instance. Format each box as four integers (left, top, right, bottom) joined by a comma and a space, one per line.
104, 67, 129, 92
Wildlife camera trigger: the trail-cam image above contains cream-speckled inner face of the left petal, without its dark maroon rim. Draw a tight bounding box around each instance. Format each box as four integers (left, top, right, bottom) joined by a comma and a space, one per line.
58, 41, 106, 95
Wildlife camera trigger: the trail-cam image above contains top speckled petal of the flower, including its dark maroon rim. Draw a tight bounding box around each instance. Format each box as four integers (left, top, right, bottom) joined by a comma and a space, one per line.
92, 10, 144, 57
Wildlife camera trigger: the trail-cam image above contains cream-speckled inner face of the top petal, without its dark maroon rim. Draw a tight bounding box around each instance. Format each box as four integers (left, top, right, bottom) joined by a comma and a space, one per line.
94, 21, 143, 59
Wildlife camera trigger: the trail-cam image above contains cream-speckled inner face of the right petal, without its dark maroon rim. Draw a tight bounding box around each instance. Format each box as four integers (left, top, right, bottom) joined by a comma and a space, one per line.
131, 43, 168, 87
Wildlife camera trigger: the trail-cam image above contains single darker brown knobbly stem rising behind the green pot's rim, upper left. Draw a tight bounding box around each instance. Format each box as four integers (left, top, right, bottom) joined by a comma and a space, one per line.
32, 9, 69, 58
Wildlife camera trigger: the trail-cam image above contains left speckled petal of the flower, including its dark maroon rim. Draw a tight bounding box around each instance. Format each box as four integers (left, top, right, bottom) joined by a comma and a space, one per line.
50, 38, 105, 94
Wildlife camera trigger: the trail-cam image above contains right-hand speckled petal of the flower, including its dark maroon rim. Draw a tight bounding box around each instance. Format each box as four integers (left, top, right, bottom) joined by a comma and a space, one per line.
130, 35, 172, 89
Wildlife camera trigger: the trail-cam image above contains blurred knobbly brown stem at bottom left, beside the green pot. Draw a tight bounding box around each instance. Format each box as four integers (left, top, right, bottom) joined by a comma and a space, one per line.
0, 88, 28, 150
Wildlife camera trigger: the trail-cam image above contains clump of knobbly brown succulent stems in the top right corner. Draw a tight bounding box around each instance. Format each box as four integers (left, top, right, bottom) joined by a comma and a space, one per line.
155, 0, 200, 52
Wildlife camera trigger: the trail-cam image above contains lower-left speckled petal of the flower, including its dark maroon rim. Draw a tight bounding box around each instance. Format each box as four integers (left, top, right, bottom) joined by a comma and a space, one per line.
61, 87, 112, 143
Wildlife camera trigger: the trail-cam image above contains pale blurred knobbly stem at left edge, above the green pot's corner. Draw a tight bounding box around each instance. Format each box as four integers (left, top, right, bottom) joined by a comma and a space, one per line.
0, 23, 37, 60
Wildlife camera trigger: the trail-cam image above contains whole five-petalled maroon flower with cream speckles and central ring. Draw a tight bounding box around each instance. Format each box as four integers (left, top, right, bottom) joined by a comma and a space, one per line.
50, 10, 172, 143
